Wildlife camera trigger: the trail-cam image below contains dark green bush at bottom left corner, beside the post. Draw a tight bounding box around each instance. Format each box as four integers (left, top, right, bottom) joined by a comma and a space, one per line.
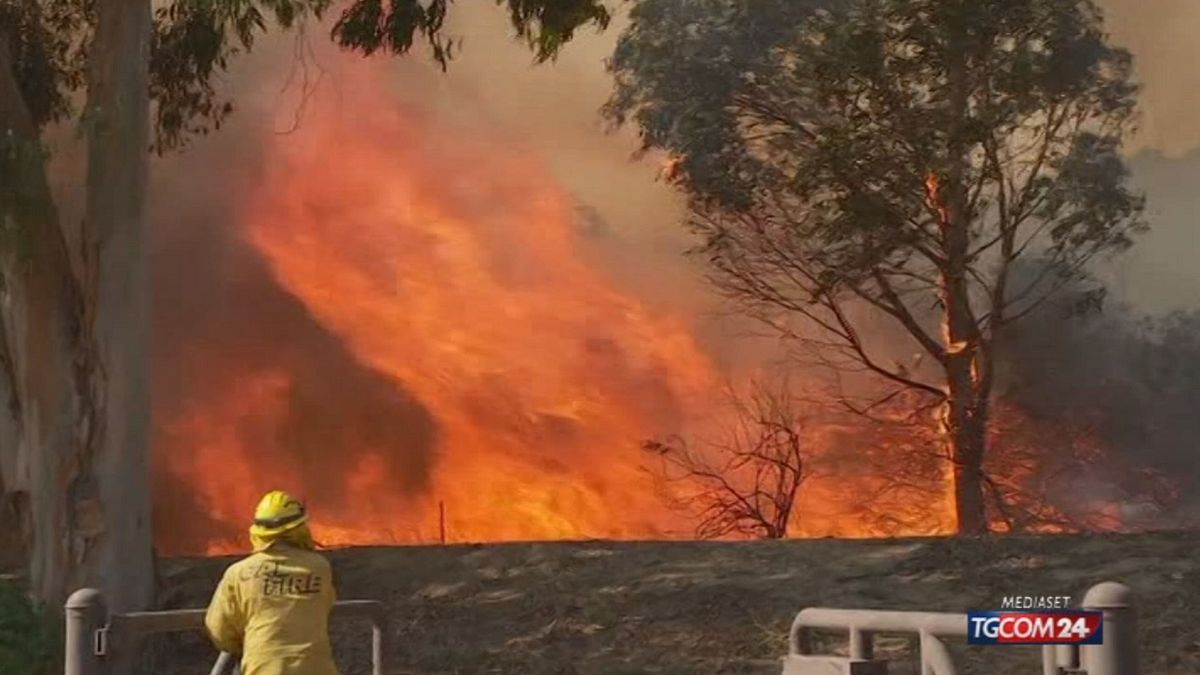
0, 581, 62, 675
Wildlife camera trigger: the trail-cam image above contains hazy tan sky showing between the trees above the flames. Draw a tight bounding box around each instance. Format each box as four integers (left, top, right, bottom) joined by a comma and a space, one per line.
162, 0, 1200, 319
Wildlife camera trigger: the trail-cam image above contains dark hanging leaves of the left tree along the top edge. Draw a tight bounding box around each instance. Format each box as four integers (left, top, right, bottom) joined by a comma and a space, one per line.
0, 0, 610, 151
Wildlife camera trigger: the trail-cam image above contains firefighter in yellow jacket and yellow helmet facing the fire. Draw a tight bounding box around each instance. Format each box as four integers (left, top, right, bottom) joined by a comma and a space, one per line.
204, 490, 337, 675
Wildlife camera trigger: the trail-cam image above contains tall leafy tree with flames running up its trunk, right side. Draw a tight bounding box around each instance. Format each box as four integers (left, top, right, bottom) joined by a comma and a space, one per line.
606, 0, 1142, 533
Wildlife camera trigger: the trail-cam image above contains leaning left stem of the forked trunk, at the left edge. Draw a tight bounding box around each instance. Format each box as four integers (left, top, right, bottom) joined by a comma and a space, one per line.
0, 36, 98, 604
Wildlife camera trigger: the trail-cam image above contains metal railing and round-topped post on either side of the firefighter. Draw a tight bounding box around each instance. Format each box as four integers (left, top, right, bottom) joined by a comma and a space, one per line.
64, 589, 388, 675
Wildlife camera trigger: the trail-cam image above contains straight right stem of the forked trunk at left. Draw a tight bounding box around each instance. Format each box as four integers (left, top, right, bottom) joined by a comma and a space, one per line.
80, 0, 155, 611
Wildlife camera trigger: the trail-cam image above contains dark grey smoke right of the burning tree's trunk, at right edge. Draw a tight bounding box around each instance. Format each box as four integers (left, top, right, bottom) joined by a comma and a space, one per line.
998, 267, 1200, 526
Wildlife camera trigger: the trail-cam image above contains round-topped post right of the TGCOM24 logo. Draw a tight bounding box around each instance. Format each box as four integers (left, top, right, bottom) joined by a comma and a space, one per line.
1080, 581, 1139, 675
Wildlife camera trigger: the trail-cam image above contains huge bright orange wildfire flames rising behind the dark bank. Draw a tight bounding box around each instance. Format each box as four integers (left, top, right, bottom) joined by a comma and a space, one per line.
147, 64, 1142, 554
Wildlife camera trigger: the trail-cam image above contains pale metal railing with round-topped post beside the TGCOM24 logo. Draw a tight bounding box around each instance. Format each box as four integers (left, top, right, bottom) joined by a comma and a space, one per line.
784, 581, 1138, 675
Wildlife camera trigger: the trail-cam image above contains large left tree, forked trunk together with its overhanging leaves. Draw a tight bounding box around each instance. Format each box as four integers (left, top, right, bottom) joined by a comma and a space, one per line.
0, 0, 608, 610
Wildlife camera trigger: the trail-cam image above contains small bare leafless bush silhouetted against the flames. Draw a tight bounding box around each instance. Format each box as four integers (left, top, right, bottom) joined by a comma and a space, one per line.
643, 383, 809, 539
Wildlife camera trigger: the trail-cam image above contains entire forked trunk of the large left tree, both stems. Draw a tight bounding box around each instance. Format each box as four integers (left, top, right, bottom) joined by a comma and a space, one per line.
0, 0, 154, 611
